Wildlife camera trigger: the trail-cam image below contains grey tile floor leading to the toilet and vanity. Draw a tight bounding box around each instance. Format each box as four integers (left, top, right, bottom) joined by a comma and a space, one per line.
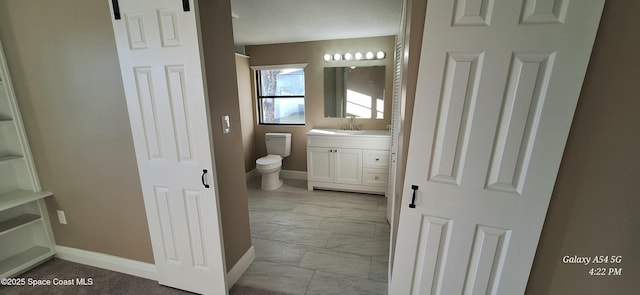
238, 177, 389, 295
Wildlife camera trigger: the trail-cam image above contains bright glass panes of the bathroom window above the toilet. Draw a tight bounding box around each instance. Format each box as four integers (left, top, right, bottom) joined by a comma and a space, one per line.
256, 66, 304, 125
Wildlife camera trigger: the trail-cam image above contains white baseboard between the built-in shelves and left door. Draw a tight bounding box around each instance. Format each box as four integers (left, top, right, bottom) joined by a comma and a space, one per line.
55, 246, 158, 281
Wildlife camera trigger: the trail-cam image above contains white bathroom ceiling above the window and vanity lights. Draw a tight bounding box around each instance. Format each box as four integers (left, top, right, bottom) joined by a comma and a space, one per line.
231, 0, 403, 46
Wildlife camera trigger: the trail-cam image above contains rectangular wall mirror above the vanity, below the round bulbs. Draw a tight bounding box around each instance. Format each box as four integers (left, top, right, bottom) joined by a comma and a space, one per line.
324, 66, 386, 119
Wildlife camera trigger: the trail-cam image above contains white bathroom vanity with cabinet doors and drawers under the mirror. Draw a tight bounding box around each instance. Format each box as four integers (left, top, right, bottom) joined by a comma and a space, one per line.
307, 129, 391, 194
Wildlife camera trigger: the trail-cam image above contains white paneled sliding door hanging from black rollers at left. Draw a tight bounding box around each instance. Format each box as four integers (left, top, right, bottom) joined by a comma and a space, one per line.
109, 0, 227, 294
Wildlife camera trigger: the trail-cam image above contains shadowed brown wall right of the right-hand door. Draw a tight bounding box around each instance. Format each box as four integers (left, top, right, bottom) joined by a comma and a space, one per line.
526, 1, 640, 295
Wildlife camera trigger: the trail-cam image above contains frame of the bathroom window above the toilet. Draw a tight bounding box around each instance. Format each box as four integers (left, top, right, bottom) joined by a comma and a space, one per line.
251, 64, 307, 126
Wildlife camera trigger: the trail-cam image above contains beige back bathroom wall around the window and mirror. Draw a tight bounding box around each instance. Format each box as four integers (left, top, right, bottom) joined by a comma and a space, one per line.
246, 36, 395, 171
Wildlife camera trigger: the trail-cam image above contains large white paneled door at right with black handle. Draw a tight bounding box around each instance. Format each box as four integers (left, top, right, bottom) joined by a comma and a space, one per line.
391, 0, 604, 295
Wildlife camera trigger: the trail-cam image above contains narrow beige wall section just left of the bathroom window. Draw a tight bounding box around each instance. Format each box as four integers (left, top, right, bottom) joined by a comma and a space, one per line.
236, 53, 256, 172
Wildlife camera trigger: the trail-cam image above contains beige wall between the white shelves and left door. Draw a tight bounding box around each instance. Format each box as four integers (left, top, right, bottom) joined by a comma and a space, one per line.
0, 0, 153, 263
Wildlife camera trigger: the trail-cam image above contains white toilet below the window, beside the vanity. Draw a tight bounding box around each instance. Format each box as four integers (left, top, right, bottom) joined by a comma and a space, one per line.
256, 133, 291, 191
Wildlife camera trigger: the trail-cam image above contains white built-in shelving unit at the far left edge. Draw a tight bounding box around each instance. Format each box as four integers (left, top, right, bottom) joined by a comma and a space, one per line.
0, 40, 55, 278
